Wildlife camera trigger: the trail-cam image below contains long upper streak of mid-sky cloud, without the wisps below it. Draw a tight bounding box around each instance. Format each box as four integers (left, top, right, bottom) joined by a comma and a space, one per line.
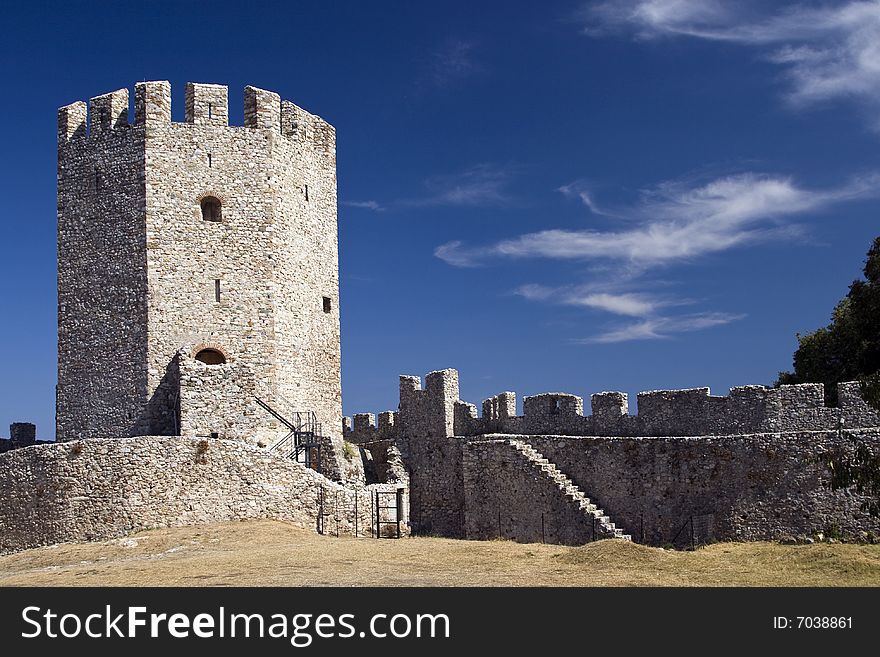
434, 173, 880, 269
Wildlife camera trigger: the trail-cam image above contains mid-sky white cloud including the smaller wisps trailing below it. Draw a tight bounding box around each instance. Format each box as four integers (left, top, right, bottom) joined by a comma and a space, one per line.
434, 173, 880, 344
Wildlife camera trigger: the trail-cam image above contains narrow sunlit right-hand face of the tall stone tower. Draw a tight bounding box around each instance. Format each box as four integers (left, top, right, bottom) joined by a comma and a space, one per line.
269, 96, 342, 456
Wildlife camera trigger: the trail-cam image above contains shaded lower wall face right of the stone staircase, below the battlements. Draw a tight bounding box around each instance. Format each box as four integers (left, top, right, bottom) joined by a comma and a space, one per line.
478, 429, 880, 545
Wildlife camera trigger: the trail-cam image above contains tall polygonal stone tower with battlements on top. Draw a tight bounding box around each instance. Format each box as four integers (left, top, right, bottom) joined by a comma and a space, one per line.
57, 82, 342, 474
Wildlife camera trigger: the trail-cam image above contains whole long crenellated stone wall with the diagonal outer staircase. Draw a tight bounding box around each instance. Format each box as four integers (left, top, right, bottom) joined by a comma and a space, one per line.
345, 370, 880, 545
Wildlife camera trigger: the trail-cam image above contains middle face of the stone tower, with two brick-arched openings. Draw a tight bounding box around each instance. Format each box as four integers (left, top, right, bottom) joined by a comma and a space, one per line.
140, 82, 277, 440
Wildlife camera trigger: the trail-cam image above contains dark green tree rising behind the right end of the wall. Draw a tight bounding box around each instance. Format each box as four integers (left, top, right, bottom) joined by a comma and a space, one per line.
776, 237, 880, 408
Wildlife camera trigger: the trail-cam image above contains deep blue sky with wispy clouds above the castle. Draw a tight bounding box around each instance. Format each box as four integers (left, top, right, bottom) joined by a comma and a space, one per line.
0, 0, 880, 438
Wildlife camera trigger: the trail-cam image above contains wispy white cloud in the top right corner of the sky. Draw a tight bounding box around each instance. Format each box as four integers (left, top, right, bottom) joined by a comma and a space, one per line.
579, 0, 880, 130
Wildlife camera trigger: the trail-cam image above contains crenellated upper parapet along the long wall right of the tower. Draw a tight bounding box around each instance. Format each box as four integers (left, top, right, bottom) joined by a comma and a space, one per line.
344, 370, 880, 442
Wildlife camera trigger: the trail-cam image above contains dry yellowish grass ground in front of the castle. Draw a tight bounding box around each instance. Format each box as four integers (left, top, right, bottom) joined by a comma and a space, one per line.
0, 521, 880, 586
